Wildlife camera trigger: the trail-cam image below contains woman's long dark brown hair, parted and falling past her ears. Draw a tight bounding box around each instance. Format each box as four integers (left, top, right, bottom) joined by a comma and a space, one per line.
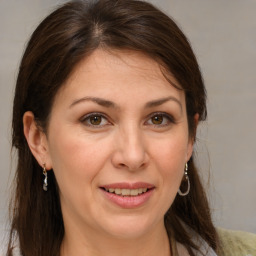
7, 0, 218, 256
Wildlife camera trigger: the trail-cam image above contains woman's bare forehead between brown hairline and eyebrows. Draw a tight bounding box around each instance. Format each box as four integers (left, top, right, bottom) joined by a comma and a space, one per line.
55, 50, 184, 106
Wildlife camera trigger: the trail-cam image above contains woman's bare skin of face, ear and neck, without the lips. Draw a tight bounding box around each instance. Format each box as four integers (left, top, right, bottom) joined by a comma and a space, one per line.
23, 50, 197, 256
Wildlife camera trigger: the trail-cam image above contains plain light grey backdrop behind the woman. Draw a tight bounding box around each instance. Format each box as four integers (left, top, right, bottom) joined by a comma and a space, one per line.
0, 0, 256, 244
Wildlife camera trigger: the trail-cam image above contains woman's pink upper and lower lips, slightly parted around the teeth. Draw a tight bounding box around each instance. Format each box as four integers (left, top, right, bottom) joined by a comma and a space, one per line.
101, 182, 155, 209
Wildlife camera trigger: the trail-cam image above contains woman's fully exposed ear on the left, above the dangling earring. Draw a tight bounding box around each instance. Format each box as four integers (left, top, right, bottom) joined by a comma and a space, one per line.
23, 111, 52, 170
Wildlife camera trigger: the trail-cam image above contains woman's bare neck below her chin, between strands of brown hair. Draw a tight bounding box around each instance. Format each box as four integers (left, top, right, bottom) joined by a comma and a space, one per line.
60, 220, 171, 256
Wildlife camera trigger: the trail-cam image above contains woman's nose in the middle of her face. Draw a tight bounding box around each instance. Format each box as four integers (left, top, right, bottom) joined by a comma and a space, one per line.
112, 128, 149, 171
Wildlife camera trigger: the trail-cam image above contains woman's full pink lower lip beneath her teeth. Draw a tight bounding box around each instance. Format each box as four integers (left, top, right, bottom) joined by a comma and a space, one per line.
102, 189, 154, 209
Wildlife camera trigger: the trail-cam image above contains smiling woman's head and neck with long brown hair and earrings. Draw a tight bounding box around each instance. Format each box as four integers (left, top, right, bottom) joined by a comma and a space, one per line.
7, 0, 255, 256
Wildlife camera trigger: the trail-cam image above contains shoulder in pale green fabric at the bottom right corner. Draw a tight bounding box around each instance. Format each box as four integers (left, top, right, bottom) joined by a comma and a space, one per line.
218, 228, 256, 256
